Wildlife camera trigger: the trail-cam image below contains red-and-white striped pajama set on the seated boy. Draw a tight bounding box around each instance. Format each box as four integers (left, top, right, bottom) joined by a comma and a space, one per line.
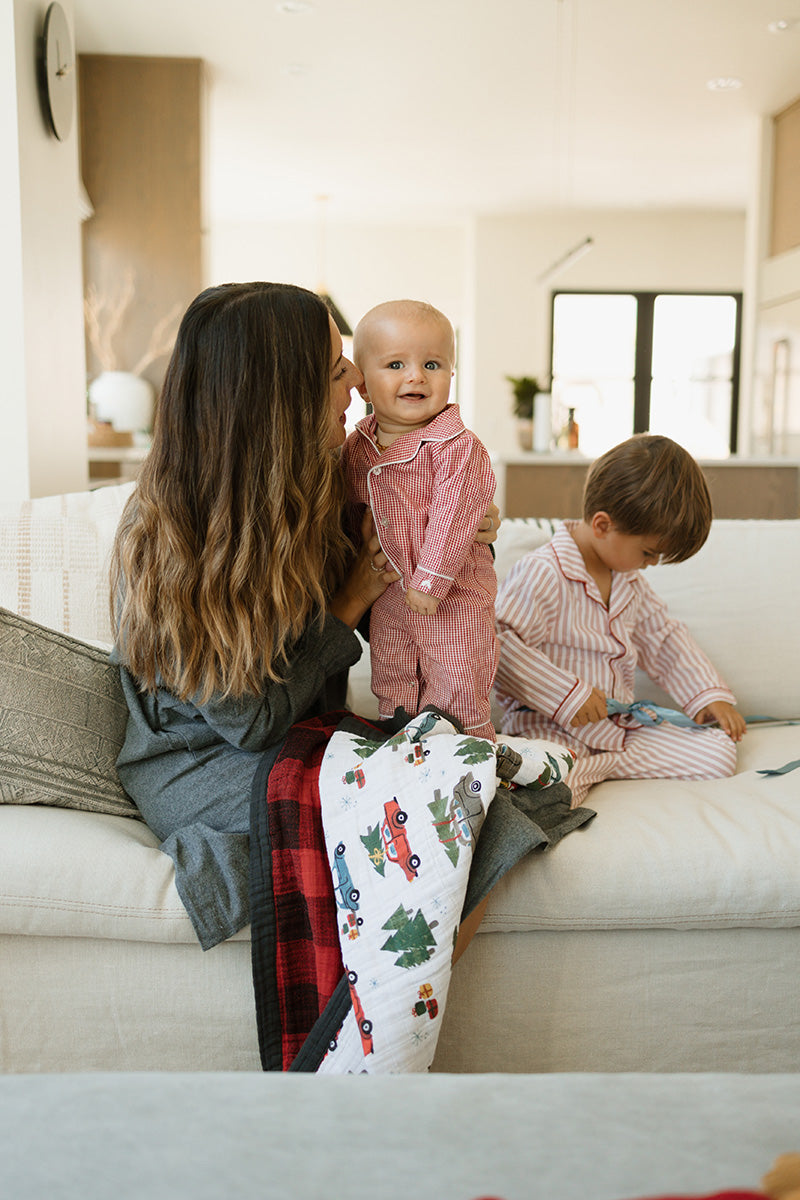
495, 521, 736, 805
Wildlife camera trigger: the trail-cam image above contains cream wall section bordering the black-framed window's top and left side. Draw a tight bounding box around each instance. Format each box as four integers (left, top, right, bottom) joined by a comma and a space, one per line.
463, 211, 745, 452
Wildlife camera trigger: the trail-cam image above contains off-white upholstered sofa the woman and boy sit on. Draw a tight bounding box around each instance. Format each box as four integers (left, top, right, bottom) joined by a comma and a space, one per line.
0, 485, 800, 1073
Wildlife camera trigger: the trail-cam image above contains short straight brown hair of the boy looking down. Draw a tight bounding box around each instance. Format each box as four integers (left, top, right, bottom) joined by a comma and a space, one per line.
583, 433, 712, 563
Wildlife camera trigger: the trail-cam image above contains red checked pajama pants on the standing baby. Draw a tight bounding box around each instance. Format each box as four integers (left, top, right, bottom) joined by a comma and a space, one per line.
369, 583, 498, 742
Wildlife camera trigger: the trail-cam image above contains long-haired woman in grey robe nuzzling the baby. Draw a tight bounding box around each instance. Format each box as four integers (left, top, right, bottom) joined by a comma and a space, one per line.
112, 283, 497, 949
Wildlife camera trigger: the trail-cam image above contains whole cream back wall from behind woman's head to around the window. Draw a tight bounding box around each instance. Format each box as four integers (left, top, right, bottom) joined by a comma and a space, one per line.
206, 211, 745, 452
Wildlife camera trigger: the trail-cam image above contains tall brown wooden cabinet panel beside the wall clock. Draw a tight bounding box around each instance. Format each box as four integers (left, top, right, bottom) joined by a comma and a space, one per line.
78, 54, 203, 451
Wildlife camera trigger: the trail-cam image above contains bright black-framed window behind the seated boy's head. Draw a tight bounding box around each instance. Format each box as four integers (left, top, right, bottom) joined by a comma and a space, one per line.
551, 292, 741, 458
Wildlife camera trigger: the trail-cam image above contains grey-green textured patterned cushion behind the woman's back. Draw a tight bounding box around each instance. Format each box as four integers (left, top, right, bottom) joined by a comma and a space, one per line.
0, 608, 139, 816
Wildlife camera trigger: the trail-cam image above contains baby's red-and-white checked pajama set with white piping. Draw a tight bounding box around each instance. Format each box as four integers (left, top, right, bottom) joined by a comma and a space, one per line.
342, 404, 497, 739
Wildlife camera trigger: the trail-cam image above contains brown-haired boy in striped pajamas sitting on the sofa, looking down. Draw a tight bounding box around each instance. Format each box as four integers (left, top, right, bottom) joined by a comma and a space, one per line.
495, 434, 745, 805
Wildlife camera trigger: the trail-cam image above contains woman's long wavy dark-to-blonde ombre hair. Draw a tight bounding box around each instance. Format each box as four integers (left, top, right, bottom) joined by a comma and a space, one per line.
112, 283, 350, 703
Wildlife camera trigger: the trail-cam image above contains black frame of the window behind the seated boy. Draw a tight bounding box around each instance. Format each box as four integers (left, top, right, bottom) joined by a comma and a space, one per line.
549, 288, 742, 454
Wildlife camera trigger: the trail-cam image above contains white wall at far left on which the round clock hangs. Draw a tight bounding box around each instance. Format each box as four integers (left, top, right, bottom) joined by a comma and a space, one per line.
0, 0, 86, 498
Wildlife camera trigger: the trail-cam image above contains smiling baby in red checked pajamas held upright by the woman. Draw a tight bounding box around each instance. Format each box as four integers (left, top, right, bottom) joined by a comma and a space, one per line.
342, 300, 497, 740
